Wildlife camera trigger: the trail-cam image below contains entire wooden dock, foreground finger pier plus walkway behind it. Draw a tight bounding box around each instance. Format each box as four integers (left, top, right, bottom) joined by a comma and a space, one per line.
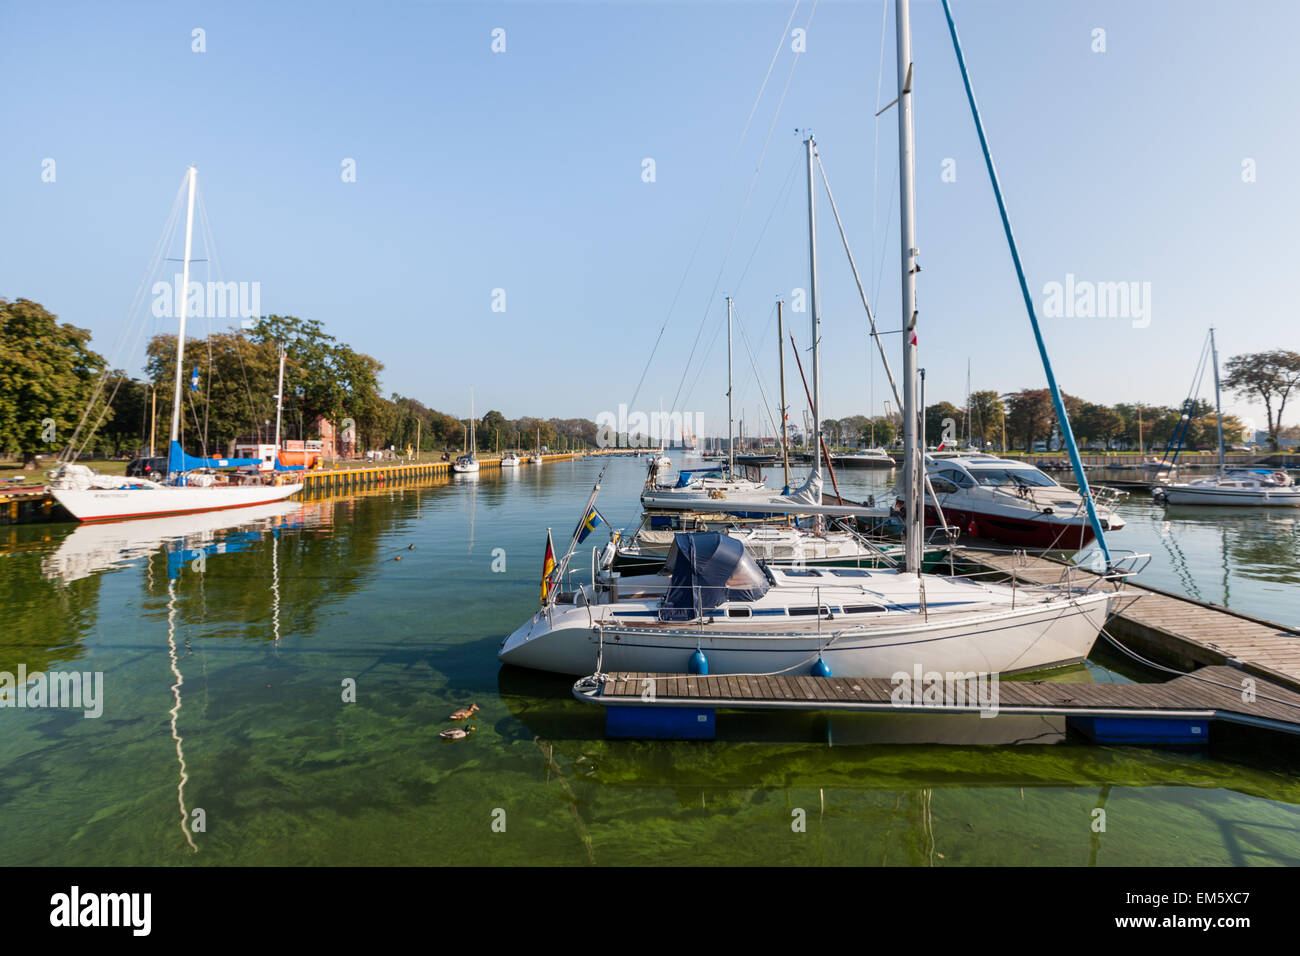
573, 545, 1300, 744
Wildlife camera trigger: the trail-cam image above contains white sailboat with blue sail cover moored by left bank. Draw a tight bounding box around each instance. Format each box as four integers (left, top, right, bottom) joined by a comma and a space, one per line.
49, 166, 303, 522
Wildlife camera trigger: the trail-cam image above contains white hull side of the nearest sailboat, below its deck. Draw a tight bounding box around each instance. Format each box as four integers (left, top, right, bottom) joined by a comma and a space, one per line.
499, 593, 1109, 678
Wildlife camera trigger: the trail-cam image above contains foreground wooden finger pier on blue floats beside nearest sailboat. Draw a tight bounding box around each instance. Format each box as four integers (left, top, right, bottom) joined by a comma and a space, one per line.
573, 666, 1300, 744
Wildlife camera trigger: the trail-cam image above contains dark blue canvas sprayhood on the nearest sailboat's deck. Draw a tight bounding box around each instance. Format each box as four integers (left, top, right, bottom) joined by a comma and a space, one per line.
659, 531, 771, 620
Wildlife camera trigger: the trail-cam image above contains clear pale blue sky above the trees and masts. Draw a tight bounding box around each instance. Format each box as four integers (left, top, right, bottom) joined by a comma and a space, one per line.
0, 0, 1300, 431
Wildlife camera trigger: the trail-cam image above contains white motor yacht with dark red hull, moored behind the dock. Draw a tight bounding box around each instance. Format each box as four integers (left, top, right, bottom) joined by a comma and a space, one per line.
896, 451, 1125, 550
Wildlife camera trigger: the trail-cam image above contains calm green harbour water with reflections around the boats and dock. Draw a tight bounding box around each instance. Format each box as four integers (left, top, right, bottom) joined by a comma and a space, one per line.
0, 459, 1300, 865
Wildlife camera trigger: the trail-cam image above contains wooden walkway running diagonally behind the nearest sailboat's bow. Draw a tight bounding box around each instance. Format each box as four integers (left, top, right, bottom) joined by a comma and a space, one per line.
956, 546, 1300, 691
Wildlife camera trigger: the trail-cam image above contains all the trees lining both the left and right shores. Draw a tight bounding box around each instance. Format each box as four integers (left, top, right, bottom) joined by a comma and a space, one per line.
0, 299, 1300, 467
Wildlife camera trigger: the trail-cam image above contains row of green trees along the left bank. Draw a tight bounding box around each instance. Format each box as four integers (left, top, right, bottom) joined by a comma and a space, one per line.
0, 299, 597, 467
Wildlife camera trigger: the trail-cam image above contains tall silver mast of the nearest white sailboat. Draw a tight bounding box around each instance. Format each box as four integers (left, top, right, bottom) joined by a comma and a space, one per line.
894, 0, 924, 574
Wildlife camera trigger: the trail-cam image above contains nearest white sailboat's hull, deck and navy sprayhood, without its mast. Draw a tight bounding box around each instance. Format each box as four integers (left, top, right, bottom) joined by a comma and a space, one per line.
499, 532, 1113, 678
